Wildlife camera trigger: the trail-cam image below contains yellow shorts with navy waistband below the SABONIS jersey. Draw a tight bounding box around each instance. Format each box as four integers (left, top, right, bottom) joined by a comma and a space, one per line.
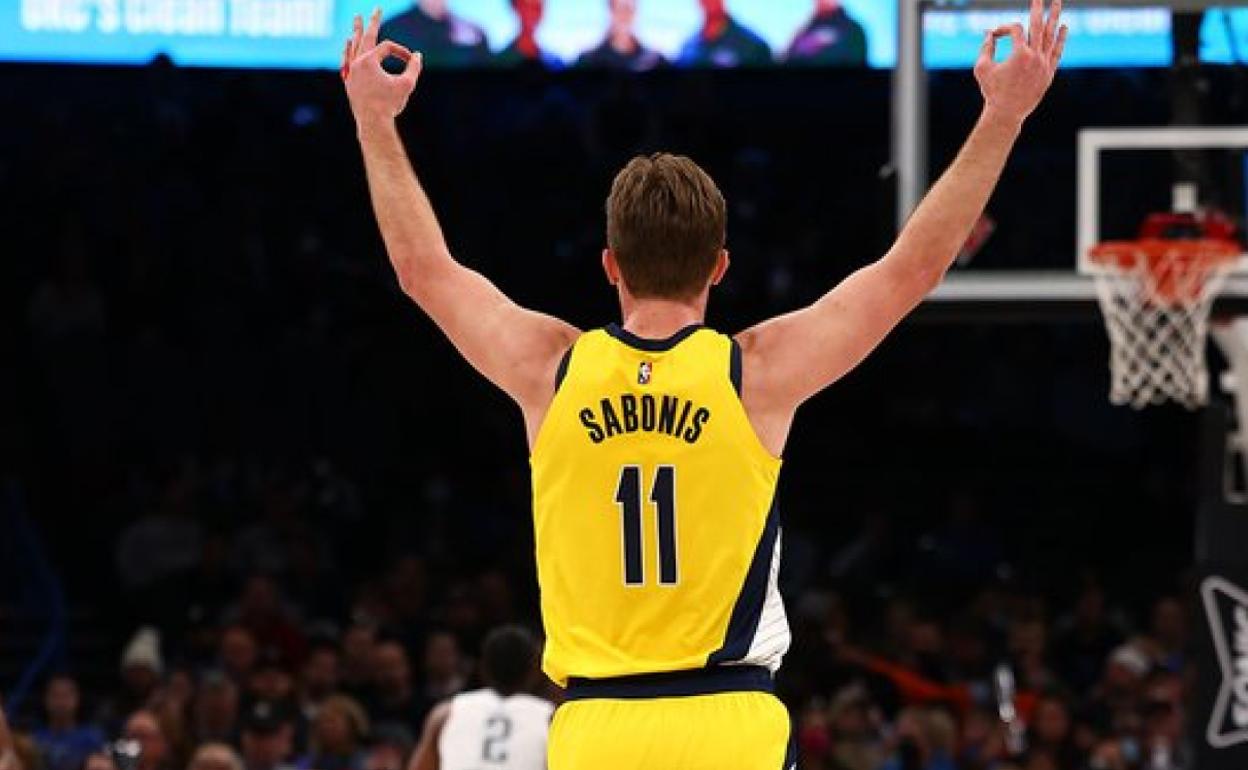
548, 674, 795, 770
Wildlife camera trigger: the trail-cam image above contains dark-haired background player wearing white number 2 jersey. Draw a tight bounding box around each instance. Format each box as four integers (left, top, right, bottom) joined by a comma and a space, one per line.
409, 625, 554, 770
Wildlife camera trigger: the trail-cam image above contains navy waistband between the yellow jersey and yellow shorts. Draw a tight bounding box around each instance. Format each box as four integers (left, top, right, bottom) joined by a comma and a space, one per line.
567, 665, 775, 700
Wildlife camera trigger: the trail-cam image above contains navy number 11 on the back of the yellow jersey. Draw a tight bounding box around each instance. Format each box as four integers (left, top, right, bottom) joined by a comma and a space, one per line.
615, 465, 676, 585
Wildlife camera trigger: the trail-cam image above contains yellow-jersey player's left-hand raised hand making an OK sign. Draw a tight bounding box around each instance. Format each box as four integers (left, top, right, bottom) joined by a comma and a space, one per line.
341, 9, 423, 125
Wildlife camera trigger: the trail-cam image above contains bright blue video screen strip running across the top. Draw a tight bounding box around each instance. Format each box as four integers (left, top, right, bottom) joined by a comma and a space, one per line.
7, 0, 1248, 71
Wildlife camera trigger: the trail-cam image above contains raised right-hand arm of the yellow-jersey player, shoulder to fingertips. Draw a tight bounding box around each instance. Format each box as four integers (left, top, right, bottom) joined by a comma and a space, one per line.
739, 0, 1066, 444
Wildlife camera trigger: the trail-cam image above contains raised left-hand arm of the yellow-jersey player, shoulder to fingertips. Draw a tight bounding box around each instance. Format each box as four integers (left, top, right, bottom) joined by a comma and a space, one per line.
342, 12, 578, 439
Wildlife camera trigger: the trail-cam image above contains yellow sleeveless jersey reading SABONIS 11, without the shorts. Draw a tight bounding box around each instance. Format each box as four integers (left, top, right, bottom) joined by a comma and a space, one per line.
530, 326, 790, 685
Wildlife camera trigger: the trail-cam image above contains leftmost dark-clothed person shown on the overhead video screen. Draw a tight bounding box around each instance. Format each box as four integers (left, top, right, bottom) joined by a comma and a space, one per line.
381, 0, 489, 67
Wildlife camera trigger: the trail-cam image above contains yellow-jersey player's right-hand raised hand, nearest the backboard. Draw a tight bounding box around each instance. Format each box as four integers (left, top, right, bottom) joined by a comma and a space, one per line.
975, 0, 1067, 122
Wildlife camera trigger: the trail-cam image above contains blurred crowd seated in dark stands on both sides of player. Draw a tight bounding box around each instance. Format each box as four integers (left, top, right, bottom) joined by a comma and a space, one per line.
6, 446, 1208, 770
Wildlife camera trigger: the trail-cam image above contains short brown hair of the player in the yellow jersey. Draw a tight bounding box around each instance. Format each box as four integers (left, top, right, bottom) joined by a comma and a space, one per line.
607, 152, 728, 300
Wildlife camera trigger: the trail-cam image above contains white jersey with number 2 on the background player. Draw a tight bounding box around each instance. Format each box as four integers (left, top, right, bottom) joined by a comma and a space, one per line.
438, 689, 554, 770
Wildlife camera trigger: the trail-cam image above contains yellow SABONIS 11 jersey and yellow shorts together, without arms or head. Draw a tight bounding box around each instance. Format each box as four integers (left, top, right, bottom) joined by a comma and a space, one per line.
532, 326, 792, 770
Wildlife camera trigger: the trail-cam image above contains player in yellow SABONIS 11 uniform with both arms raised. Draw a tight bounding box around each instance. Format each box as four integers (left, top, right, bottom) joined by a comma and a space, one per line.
343, 0, 1066, 770
